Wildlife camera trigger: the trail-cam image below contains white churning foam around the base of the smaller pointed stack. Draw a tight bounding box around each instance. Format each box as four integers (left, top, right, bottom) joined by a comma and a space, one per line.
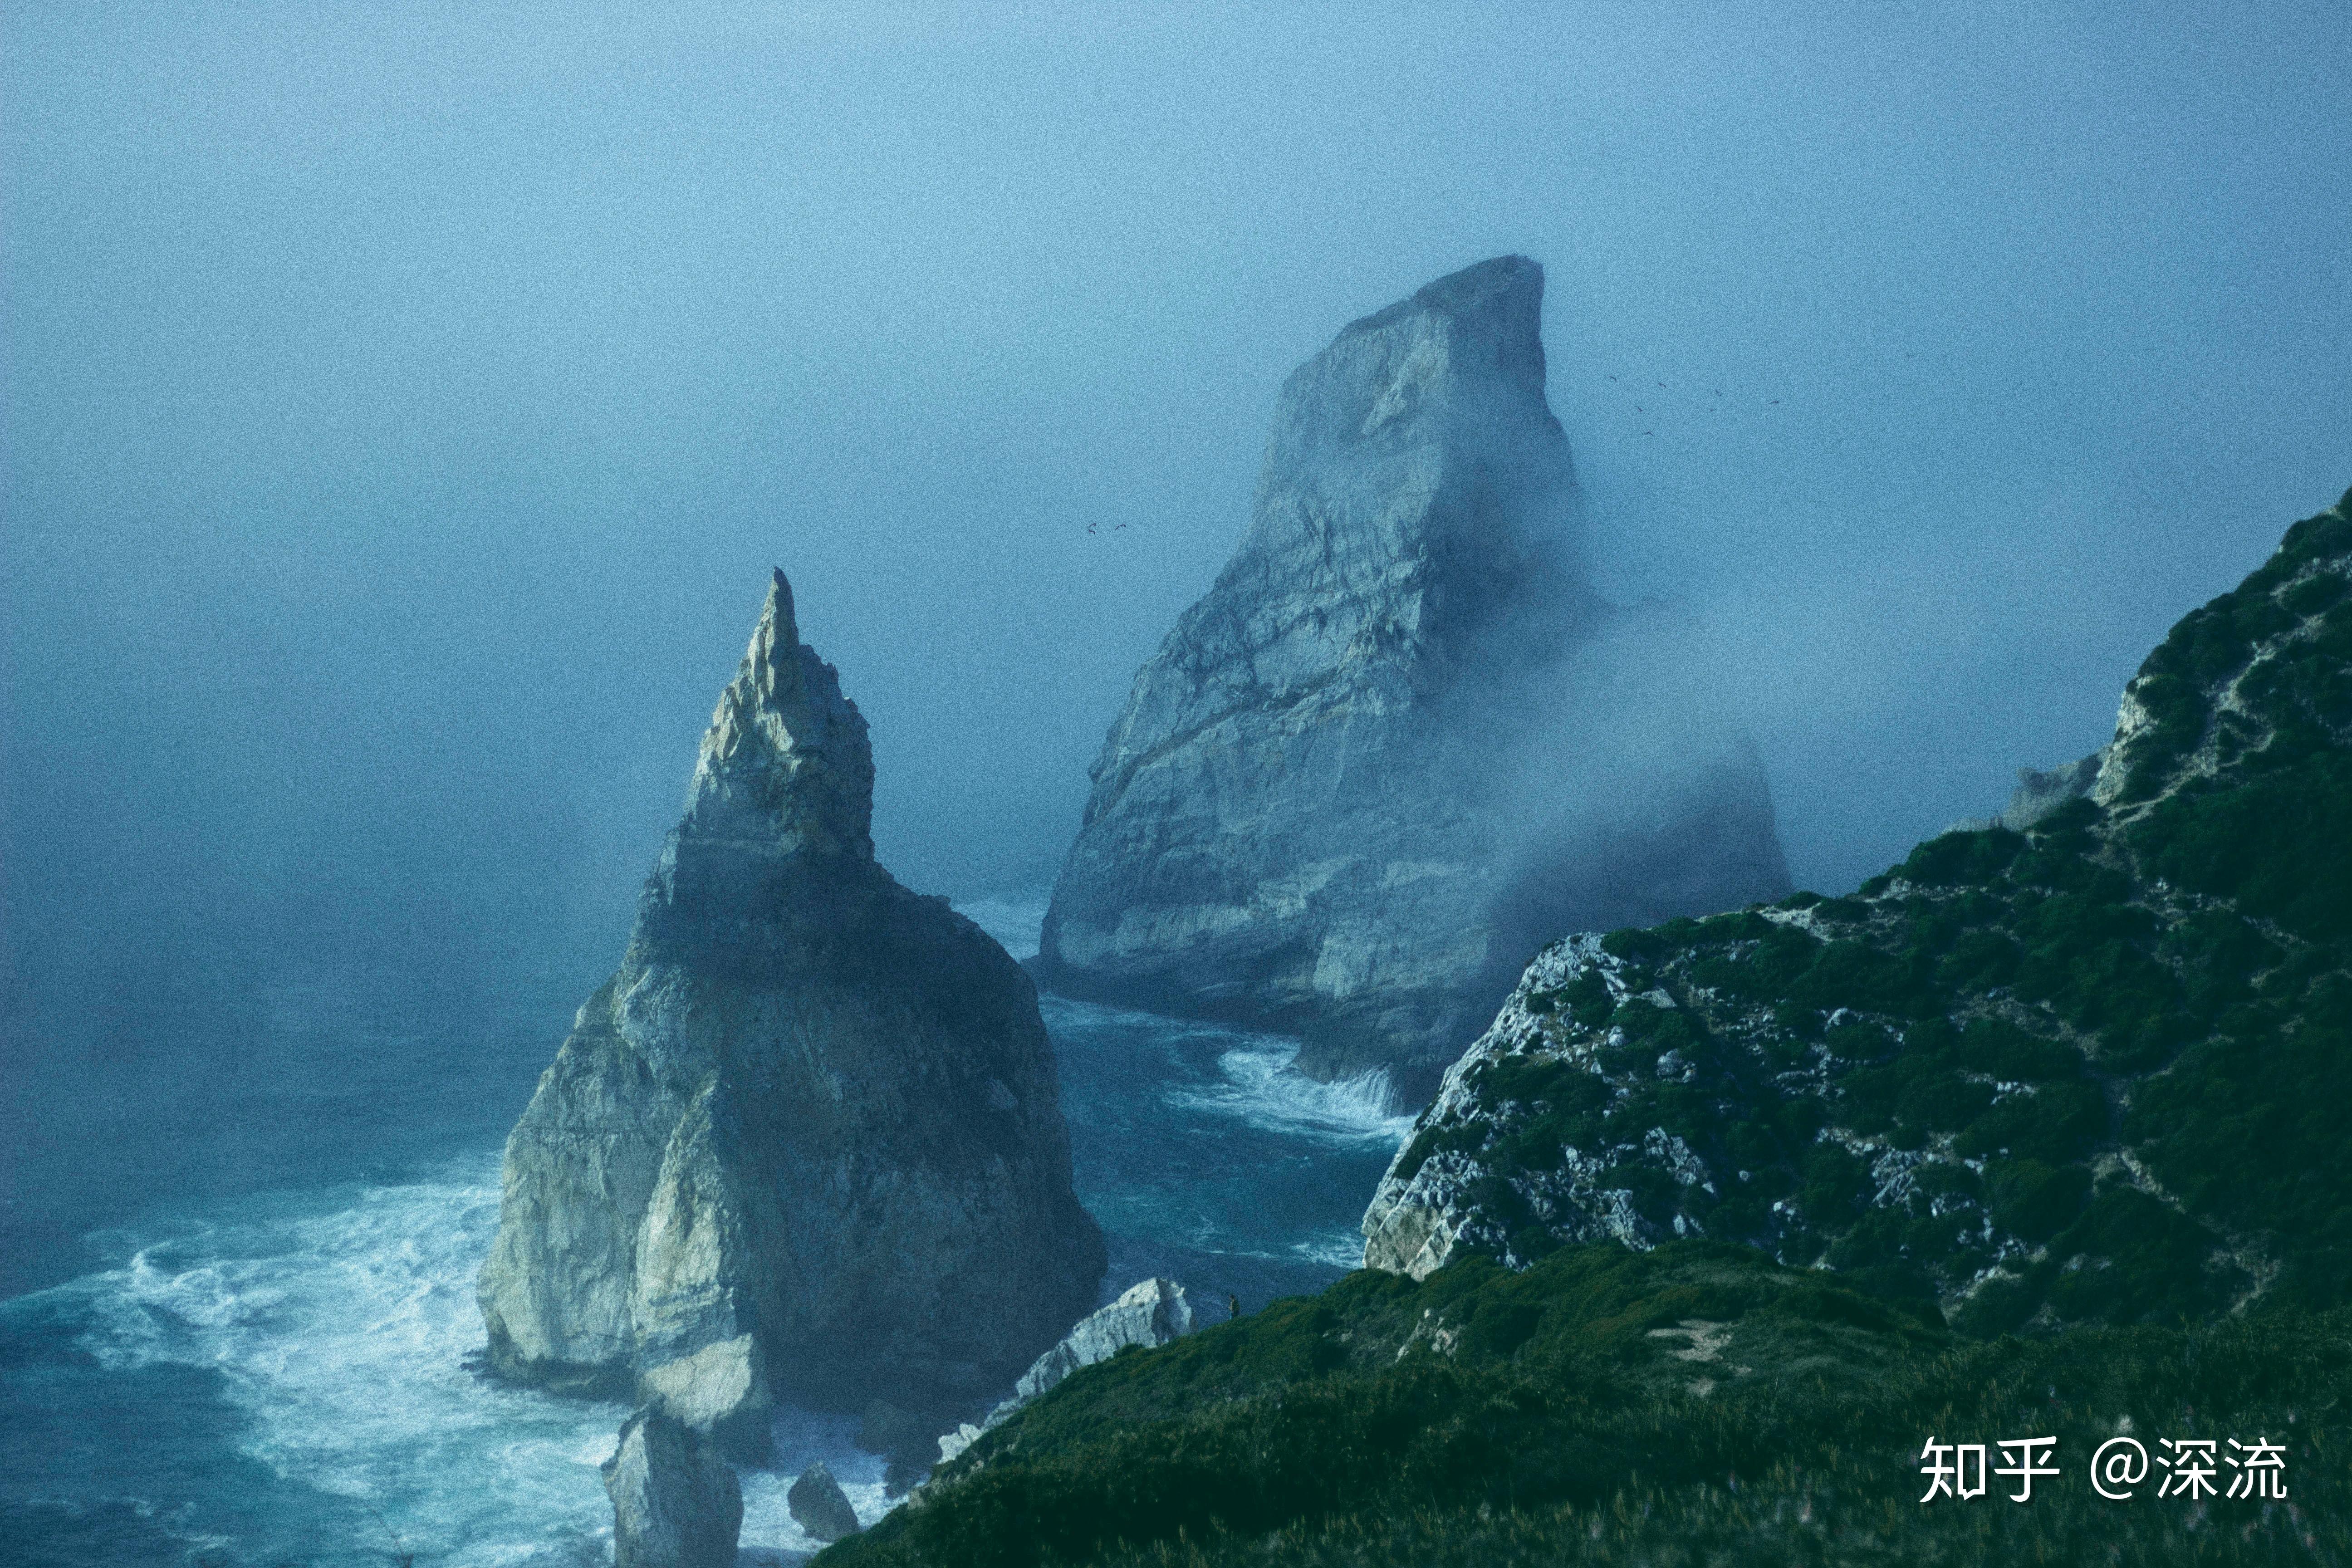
59, 1159, 908, 1568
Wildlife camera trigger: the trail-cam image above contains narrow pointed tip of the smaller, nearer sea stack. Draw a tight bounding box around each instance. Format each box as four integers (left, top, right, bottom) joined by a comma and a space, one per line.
680, 569, 875, 860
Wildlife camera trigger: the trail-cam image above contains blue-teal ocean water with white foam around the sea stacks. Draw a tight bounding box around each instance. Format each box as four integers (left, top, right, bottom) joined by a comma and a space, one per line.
0, 898, 1409, 1568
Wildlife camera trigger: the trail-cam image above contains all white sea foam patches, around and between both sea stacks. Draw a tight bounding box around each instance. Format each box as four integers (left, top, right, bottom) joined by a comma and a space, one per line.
10, 964, 1411, 1568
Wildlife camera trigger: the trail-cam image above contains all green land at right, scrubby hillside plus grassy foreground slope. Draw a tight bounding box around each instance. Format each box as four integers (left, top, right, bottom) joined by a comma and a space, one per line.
821, 494, 2352, 1568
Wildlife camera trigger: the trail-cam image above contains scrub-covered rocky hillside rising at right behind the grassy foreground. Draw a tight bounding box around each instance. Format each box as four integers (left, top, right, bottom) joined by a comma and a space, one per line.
1364, 496, 2352, 1333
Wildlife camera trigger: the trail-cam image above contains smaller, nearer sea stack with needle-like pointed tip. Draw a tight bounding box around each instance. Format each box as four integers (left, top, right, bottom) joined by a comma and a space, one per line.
480, 571, 1103, 1455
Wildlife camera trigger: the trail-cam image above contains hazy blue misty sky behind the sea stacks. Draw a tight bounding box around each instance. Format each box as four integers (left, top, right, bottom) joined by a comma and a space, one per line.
0, 0, 2352, 1001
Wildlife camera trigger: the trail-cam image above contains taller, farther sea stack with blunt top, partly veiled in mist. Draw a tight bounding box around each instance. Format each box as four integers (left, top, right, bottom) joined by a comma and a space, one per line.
1037, 256, 1788, 1098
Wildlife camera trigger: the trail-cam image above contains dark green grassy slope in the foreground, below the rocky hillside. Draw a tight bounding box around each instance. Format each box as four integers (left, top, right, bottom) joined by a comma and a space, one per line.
818, 1241, 2352, 1568
